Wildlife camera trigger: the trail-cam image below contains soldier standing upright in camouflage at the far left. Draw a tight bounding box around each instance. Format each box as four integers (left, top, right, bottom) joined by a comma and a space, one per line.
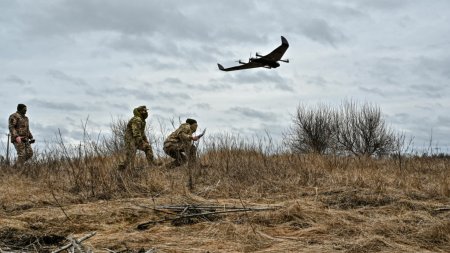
8, 104, 34, 166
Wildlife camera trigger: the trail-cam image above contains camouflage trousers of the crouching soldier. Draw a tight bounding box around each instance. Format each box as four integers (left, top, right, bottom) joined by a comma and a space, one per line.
163, 142, 197, 167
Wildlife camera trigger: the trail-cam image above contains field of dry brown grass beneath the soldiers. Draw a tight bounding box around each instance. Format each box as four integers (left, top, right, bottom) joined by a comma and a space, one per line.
0, 147, 450, 252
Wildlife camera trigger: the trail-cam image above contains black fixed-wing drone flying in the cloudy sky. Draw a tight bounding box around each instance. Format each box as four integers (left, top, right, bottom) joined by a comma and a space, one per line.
217, 36, 289, 71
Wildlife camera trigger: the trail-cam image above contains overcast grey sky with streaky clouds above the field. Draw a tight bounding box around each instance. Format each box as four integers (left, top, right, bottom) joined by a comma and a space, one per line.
0, 0, 450, 152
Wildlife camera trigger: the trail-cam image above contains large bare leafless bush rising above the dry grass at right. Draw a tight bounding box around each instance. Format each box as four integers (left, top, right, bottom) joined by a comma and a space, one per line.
284, 101, 404, 156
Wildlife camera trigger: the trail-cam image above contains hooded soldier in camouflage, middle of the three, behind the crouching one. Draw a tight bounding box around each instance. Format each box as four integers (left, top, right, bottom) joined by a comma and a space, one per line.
119, 105, 159, 170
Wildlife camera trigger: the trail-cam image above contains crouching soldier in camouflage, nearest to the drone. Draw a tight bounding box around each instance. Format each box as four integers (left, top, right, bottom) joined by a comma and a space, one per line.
163, 119, 200, 168
